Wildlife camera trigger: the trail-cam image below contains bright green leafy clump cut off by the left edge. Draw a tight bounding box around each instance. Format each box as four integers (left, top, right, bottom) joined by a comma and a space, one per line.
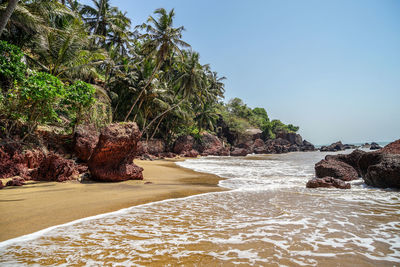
0, 41, 26, 90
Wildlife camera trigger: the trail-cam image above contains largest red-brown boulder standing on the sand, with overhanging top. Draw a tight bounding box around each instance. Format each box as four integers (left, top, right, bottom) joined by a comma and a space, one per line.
88, 122, 143, 182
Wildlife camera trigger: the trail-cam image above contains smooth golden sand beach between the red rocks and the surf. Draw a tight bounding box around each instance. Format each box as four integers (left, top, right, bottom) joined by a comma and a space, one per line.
0, 160, 224, 241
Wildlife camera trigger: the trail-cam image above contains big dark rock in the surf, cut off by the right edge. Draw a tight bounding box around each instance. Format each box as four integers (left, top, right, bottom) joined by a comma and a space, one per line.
363, 154, 400, 188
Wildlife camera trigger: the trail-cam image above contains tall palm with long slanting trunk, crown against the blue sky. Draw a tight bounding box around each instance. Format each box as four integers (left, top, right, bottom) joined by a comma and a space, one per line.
125, 8, 190, 121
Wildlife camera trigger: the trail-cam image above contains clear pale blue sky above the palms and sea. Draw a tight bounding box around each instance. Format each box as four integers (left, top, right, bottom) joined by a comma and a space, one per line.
82, 0, 400, 147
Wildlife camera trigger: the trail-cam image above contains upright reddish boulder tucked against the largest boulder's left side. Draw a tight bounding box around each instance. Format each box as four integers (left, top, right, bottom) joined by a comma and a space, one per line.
74, 125, 99, 162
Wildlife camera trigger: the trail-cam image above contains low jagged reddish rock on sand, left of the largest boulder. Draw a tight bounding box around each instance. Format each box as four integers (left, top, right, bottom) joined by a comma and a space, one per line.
31, 153, 79, 182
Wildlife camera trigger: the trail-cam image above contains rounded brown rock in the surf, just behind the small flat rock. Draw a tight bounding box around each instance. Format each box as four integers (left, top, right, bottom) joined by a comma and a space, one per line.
315, 159, 358, 181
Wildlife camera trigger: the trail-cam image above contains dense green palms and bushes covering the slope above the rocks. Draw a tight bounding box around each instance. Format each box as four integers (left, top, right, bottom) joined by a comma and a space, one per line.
0, 0, 298, 147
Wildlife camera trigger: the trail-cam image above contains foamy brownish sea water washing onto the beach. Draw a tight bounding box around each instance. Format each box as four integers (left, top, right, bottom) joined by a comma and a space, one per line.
0, 151, 400, 266
